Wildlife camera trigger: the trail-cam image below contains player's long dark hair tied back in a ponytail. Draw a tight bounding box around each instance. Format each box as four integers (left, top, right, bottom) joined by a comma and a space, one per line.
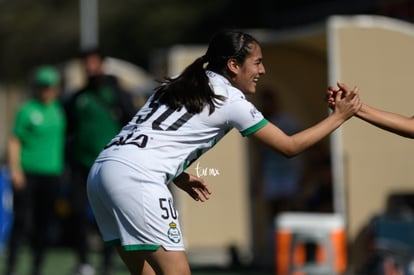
154, 30, 258, 114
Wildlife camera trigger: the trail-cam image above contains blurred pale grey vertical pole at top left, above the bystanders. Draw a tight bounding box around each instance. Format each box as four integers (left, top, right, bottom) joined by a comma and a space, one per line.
79, 0, 98, 50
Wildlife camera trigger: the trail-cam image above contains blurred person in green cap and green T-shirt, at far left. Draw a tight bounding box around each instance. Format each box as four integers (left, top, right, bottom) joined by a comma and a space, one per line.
6, 65, 66, 275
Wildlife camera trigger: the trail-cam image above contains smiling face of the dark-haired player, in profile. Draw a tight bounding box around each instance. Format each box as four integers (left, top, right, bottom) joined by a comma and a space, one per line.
229, 43, 266, 94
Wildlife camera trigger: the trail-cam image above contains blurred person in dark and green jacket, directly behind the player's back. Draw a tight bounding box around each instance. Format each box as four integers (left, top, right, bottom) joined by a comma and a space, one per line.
65, 49, 136, 275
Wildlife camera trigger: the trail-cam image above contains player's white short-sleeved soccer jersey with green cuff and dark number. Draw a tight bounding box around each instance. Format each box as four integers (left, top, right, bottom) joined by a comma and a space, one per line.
97, 71, 267, 187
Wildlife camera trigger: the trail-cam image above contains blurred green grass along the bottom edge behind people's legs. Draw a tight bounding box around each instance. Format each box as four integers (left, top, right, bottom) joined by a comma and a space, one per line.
0, 248, 273, 275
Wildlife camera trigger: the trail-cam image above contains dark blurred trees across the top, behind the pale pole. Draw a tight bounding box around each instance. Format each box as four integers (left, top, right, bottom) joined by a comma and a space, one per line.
0, 0, 414, 85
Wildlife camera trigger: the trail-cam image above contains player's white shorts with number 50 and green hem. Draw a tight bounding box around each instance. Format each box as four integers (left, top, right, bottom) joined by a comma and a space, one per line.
87, 160, 184, 251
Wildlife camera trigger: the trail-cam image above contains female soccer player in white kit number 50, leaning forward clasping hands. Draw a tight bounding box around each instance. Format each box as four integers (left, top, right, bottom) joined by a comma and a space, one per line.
88, 31, 361, 275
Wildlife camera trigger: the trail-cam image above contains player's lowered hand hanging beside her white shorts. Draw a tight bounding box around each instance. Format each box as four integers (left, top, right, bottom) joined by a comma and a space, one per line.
174, 172, 211, 202
